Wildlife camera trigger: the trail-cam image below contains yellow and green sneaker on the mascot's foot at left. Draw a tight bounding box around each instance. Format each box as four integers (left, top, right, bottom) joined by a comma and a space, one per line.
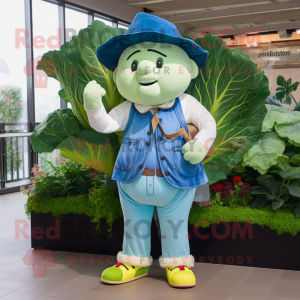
101, 263, 149, 284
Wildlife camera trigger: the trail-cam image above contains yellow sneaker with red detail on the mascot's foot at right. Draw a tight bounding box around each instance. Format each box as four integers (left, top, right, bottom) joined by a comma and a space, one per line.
165, 266, 196, 288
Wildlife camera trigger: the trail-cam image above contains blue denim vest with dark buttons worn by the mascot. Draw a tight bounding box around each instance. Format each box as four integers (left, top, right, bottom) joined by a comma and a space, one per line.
112, 98, 208, 189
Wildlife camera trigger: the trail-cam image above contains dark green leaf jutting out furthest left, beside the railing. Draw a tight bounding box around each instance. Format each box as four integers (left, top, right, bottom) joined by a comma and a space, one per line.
31, 108, 84, 153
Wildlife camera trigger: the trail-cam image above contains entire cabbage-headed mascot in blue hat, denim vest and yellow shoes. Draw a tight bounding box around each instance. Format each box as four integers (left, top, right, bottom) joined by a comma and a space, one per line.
83, 13, 216, 287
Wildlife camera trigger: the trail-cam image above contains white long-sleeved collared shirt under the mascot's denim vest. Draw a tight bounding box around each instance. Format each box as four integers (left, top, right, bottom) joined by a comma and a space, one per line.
86, 93, 216, 150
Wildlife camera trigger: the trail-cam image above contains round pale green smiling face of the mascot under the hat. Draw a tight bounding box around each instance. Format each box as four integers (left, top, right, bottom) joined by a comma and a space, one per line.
113, 42, 198, 105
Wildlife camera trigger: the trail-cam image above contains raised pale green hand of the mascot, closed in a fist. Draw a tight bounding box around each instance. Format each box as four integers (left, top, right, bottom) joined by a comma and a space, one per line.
83, 80, 106, 110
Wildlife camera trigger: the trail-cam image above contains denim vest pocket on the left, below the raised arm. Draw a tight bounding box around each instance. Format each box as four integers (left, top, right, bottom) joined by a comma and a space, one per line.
116, 138, 139, 172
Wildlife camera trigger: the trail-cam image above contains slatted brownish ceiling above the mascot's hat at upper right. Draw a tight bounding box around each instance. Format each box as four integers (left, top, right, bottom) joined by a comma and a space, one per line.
118, 0, 300, 37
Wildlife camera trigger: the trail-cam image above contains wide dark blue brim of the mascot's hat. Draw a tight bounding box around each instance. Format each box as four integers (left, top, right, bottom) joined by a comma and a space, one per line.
97, 31, 209, 72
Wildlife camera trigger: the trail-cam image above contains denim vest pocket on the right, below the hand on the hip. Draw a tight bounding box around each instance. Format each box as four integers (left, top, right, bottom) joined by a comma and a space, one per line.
173, 147, 202, 178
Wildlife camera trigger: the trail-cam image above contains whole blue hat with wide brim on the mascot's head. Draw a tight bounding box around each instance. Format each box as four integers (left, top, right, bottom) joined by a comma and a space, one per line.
97, 12, 208, 71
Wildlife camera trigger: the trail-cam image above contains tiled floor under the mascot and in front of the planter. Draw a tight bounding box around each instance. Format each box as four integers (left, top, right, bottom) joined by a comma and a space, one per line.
0, 193, 300, 300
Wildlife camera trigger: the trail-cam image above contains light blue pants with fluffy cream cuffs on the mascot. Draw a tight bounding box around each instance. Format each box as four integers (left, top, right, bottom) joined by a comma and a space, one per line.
118, 176, 196, 267
